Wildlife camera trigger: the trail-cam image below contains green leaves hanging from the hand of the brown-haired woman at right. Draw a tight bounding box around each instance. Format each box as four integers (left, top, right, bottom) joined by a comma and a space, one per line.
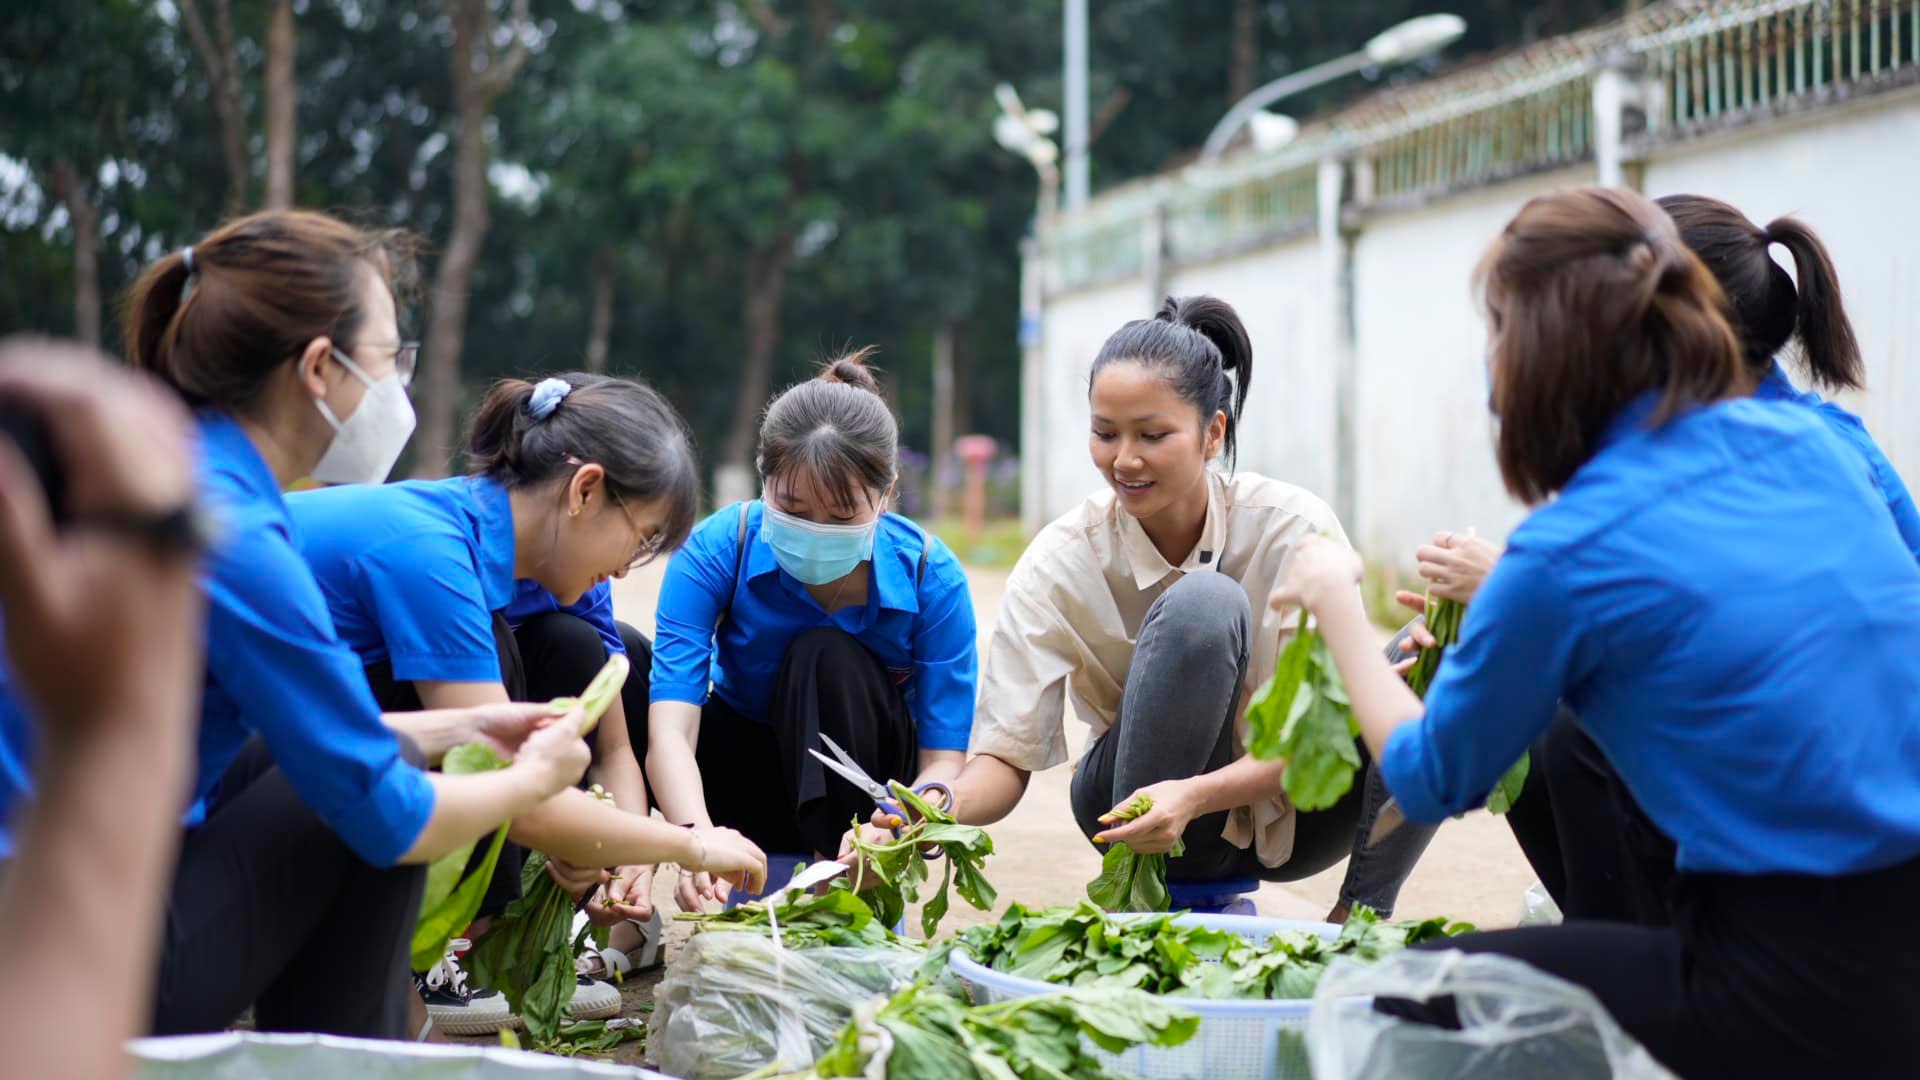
1246, 609, 1359, 811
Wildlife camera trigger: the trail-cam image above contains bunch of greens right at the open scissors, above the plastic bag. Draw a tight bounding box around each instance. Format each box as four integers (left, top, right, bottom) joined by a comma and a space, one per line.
852, 780, 998, 940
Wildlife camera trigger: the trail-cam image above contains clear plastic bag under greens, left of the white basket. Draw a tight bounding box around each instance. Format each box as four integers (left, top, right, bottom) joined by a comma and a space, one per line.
647, 930, 925, 1080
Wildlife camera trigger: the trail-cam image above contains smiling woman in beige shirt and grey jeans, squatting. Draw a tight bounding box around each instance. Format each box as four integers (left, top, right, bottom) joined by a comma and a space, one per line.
936, 296, 1432, 919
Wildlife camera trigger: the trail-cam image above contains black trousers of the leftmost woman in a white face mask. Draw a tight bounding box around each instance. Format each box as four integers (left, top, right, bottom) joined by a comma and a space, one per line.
154, 736, 426, 1038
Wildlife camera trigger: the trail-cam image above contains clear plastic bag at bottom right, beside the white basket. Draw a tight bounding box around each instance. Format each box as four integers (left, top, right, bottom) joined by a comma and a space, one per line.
1308, 949, 1672, 1080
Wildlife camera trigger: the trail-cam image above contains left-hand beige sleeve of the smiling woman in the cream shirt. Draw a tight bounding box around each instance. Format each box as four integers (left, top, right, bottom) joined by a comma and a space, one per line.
970, 557, 1077, 773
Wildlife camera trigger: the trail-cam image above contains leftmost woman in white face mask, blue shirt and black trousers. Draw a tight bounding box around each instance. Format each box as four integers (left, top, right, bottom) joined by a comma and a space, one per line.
0, 211, 588, 1038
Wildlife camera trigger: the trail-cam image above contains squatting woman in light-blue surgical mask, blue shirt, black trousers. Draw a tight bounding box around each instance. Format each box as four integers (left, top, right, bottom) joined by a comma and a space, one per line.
647, 352, 975, 909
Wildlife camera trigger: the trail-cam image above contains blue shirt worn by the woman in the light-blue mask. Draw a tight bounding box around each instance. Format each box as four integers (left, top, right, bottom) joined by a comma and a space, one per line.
651, 502, 979, 749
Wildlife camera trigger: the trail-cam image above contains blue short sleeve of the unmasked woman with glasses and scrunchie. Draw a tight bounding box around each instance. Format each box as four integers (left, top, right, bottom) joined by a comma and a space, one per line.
351, 532, 501, 682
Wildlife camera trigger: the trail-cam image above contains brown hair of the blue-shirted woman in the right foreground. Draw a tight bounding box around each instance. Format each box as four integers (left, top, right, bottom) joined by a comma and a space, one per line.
1473, 188, 1751, 503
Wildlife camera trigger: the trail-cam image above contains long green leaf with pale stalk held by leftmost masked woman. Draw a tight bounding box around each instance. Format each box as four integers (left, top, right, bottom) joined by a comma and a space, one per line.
411, 653, 630, 970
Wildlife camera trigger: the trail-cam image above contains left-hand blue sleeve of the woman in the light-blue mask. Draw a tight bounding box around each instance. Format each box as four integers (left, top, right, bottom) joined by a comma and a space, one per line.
649, 505, 741, 705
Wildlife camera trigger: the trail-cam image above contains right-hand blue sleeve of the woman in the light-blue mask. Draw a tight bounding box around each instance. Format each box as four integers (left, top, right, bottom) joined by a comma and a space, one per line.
912, 536, 979, 749
